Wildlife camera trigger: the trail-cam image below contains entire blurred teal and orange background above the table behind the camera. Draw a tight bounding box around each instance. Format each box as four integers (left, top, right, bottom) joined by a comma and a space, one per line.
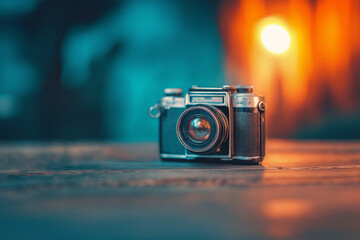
0, 0, 360, 141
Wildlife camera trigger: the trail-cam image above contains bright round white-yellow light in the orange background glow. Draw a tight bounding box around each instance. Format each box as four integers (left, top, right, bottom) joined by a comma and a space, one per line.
261, 24, 290, 53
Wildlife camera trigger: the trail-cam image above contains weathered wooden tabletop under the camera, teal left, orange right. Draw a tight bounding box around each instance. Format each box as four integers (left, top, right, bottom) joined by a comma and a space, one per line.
0, 140, 360, 240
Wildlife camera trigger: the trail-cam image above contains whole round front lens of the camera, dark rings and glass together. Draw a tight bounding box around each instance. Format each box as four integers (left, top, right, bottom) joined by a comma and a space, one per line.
177, 105, 228, 154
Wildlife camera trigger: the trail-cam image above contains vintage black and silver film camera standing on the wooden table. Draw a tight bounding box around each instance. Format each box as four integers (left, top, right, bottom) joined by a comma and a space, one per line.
150, 85, 265, 164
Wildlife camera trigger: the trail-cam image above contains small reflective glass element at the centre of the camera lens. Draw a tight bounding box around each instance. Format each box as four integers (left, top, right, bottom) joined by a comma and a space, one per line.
188, 117, 211, 141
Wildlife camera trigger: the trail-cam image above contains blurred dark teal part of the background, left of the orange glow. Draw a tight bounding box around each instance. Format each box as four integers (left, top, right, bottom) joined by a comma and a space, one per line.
0, 0, 224, 141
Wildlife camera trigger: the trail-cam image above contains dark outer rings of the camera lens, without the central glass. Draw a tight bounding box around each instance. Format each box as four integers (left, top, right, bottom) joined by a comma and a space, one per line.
176, 105, 229, 153
